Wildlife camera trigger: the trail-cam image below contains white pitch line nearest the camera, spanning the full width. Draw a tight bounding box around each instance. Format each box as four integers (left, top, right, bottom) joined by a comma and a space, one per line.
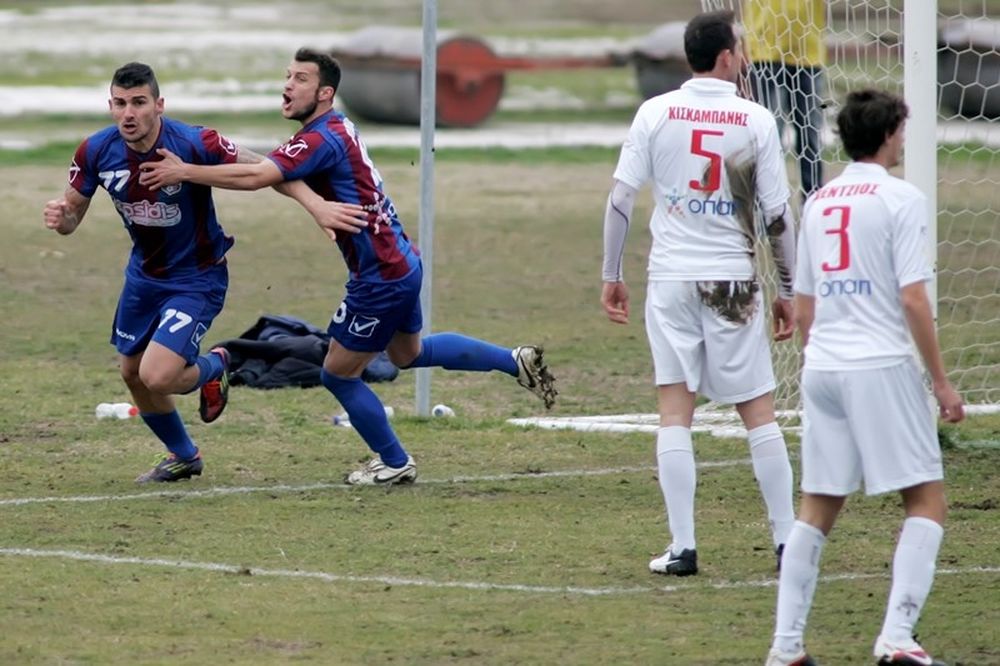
0, 548, 1000, 597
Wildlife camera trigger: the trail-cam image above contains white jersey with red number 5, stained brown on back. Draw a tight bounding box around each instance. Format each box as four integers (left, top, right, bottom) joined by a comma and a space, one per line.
614, 78, 789, 280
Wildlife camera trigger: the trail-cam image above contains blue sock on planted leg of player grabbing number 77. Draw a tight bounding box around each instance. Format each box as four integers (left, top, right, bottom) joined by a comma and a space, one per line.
319, 368, 409, 467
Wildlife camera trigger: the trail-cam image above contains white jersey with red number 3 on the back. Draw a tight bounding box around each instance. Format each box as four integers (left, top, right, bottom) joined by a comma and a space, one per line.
795, 162, 932, 370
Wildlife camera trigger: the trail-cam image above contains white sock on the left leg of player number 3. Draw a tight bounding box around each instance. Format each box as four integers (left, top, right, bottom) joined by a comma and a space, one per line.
771, 520, 826, 652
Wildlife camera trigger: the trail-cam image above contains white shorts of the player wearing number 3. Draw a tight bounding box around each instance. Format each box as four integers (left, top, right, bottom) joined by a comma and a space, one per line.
802, 359, 944, 496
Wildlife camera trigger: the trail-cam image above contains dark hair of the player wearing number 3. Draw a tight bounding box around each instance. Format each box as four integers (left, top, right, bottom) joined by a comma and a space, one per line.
837, 88, 910, 160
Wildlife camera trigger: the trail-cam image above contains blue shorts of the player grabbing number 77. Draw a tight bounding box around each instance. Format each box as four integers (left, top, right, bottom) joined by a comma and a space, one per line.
327, 266, 424, 352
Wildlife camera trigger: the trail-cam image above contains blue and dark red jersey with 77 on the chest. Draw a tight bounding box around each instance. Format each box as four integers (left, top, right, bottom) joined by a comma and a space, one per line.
69, 117, 238, 280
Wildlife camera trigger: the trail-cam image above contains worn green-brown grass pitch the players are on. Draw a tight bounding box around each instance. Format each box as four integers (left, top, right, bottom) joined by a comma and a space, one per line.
0, 151, 1000, 666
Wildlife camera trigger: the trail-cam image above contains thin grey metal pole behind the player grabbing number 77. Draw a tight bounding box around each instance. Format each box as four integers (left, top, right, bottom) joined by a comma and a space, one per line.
415, 0, 437, 416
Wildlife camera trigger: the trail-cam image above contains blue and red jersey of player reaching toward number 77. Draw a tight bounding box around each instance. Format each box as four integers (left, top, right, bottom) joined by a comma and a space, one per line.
268, 111, 420, 282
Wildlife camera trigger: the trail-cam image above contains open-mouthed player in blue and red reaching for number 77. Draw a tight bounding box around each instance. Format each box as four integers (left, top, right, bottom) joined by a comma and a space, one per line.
141, 49, 556, 485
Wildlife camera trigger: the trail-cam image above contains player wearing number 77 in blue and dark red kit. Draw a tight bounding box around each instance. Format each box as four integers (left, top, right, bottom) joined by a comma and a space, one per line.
43, 62, 348, 483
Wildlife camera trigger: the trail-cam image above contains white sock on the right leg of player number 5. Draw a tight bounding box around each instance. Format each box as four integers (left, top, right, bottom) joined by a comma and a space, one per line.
747, 421, 795, 547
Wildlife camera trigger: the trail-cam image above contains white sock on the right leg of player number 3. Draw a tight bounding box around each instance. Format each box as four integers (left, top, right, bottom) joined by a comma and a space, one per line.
882, 518, 944, 644
